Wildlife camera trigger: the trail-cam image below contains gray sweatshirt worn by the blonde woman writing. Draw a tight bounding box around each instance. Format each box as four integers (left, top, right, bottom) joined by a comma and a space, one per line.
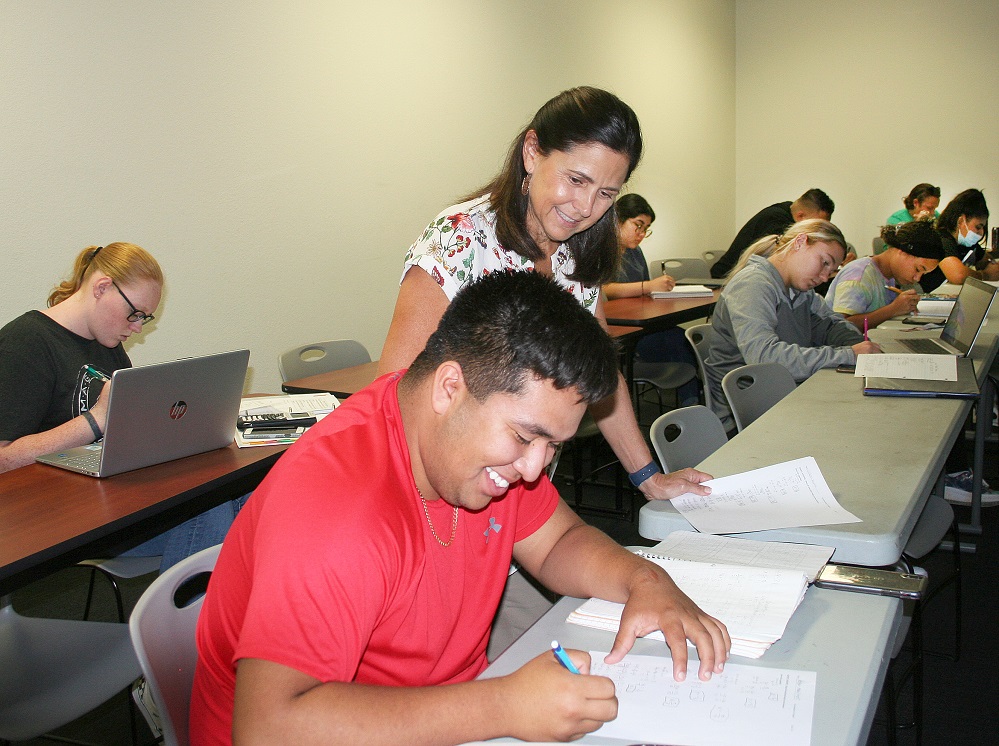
704, 256, 864, 430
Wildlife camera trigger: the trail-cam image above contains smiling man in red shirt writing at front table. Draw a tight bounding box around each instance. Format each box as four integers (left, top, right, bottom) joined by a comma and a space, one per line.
190, 271, 730, 746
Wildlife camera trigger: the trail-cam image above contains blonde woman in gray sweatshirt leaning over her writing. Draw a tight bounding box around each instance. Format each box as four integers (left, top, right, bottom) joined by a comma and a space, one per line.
704, 219, 881, 430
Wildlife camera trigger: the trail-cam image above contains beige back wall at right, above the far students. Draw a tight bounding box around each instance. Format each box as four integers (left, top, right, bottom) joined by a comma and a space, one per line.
725, 0, 999, 254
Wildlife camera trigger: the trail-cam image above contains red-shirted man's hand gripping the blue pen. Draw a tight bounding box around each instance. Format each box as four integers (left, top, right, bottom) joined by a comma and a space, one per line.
505, 650, 617, 741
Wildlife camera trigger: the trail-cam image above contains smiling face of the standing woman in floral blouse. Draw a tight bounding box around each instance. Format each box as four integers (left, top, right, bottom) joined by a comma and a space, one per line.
523, 130, 629, 256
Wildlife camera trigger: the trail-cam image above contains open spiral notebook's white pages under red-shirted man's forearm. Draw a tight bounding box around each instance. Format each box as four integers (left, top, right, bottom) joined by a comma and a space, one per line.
567, 553, 808, 658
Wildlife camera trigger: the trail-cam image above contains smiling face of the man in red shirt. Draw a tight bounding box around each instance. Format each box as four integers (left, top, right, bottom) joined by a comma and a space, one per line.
422, 370, 586, 511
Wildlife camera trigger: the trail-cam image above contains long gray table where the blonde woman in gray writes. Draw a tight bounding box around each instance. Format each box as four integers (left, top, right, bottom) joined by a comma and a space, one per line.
639, 330, 999, 566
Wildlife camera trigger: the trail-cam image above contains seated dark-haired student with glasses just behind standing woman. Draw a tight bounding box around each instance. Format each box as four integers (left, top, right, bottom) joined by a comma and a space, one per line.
604, 194, 698, 407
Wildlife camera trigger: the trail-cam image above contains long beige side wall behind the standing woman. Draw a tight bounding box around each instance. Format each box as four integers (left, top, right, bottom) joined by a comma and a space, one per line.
0, 0, 735, 391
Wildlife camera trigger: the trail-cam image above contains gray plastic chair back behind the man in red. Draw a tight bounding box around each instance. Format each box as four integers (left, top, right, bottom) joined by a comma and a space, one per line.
128, 544, 222, 746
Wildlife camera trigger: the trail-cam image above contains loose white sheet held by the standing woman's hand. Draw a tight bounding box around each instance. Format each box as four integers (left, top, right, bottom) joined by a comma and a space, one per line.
672, 456, 861, 534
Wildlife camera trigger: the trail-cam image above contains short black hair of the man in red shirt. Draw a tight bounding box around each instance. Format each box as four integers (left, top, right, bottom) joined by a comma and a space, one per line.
406, 271, 618, 404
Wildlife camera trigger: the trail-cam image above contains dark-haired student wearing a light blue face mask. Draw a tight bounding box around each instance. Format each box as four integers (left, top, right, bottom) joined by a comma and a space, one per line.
919, 189, 999, 293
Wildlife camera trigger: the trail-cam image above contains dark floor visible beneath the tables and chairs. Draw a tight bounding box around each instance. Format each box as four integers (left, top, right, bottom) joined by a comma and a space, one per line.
7, 410, 999, 746
